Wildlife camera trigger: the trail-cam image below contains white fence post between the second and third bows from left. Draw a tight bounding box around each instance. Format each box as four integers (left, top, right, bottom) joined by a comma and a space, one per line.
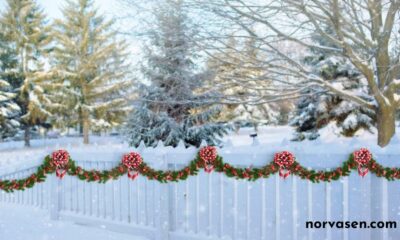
156, 153, 170, 240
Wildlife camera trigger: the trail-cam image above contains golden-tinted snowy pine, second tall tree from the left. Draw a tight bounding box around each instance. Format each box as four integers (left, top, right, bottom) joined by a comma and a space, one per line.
53, 0, 131, 144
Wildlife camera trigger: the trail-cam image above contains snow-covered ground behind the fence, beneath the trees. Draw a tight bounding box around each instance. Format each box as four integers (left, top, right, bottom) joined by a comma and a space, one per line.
0, 124, 400, 161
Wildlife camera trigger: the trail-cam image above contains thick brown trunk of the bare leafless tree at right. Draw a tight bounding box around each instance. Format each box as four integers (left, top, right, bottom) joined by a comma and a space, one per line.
377, 106, 396, 147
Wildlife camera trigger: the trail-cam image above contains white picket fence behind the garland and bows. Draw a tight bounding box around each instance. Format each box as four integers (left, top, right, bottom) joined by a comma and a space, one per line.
0, 141, 400, 240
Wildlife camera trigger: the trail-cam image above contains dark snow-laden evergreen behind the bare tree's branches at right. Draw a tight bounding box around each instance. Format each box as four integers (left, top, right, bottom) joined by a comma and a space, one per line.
291, 29, 376, 141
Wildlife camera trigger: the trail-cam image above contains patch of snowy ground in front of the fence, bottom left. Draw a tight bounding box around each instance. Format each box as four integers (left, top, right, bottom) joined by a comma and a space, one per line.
0, 203, 146, 240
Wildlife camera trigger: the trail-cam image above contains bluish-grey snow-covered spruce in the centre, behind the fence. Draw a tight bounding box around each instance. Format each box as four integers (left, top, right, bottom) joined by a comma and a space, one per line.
125, 0, 231, 146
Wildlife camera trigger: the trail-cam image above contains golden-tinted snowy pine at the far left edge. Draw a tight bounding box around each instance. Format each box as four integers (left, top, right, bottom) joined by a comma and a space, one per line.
0, 0, 56, 146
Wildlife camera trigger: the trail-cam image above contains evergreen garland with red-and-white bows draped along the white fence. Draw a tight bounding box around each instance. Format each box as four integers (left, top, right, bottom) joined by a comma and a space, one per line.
0, 146, 400, 192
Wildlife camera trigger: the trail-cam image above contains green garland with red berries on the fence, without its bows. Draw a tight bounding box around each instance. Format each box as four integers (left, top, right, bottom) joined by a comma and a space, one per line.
0, 147, 400, 192
